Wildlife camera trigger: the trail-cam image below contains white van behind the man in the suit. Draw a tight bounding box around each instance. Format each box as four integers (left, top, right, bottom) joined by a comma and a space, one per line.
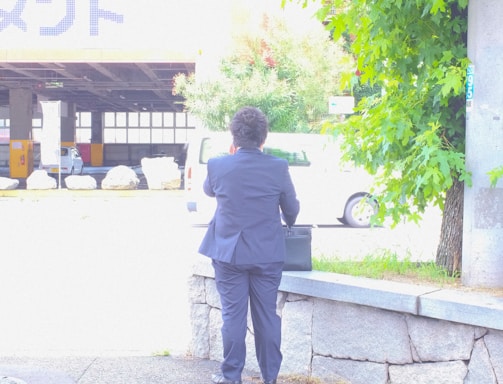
185, 132, 378, 228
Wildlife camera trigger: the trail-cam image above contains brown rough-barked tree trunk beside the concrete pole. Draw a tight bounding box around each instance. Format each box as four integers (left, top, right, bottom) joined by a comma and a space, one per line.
436, 179, 464, 276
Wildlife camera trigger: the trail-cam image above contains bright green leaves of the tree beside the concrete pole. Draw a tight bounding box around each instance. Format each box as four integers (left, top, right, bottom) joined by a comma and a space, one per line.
312, 0, 470, 223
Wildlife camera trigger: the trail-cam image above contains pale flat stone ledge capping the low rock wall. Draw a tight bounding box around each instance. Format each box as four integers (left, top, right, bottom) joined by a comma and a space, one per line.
193, 256, 503, 330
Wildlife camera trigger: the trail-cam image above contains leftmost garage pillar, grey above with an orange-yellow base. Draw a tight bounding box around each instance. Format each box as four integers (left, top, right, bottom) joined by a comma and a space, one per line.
9, 88, 33, 178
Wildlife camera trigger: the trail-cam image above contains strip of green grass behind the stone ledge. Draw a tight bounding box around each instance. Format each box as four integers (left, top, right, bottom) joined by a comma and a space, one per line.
313, 251, 459, 285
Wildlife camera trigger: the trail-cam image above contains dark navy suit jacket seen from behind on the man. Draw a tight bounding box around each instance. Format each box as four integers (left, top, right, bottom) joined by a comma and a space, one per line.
199, 148, 299, 264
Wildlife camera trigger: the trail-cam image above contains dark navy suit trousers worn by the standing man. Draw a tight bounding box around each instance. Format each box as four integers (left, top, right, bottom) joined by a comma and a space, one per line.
213, 260, 283, 381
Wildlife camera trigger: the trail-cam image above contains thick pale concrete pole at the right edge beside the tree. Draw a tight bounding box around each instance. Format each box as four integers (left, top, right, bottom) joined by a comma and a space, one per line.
462, 0, 503, 287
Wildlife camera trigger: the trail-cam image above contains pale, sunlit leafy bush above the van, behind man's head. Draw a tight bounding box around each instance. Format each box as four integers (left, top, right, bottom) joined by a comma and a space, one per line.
174, 9, 354, 132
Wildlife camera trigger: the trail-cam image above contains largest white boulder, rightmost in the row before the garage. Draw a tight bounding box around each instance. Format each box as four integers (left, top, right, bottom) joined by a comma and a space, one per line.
141, 157, 180, 189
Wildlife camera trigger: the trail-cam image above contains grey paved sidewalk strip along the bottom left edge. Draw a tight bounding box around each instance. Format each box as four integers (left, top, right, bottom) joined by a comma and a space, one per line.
0, 356, 268, 384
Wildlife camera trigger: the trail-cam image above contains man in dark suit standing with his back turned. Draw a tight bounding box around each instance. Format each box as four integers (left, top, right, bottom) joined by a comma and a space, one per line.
199, 107, 299, 384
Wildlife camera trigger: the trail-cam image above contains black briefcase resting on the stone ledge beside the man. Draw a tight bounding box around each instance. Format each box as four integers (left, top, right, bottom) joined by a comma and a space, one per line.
283, 226, 313, 271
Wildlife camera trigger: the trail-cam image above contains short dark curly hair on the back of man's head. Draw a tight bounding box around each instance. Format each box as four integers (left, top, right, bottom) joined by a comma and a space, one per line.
230, 107, 269, 148
